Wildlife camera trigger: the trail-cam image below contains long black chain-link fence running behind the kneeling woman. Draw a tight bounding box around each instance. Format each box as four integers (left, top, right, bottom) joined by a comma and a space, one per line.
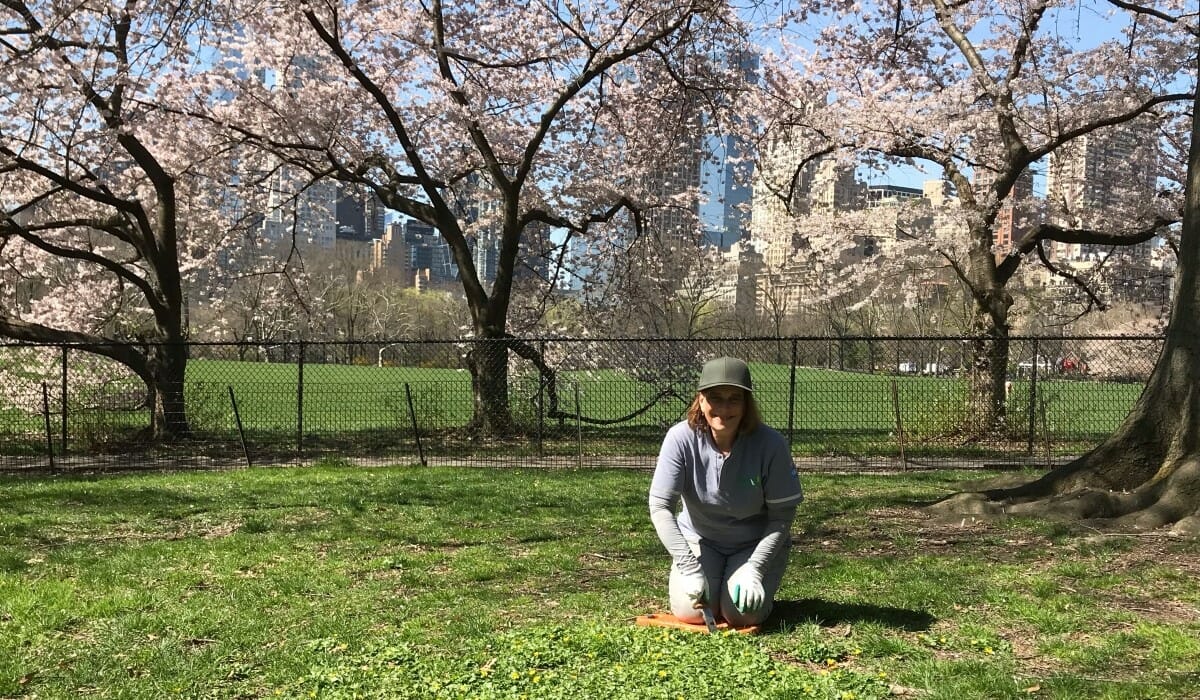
0, 336, 1162, 469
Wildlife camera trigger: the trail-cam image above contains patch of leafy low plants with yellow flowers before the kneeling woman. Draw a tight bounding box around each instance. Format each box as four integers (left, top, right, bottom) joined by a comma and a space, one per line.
277, 624, 888, 700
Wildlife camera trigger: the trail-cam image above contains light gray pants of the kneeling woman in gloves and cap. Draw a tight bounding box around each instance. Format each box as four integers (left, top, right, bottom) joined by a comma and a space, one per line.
668, 540, 791, 627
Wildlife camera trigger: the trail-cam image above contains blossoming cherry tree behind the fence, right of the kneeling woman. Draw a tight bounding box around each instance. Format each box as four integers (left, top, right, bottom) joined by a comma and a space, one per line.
762, 0, 1196, 432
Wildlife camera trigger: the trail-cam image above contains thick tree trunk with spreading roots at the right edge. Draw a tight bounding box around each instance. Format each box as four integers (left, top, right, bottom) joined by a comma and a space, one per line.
932, 72, 1200, 536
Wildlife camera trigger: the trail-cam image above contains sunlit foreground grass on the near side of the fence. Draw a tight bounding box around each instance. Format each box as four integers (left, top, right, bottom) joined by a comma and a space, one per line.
0, 463, 1200, 700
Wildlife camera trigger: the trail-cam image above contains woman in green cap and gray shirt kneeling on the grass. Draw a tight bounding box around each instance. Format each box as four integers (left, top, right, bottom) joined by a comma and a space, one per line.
650, 358, 804, 627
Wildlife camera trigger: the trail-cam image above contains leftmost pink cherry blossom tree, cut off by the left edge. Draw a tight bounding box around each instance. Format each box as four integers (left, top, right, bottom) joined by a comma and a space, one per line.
0, 0, 241, 437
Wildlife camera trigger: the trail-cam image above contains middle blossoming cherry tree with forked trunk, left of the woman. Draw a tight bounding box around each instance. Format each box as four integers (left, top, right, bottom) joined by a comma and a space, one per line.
193, 0, 753, 435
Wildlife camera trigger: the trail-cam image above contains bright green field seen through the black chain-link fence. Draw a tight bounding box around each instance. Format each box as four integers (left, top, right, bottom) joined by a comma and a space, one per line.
0, 359, 1141, 463
